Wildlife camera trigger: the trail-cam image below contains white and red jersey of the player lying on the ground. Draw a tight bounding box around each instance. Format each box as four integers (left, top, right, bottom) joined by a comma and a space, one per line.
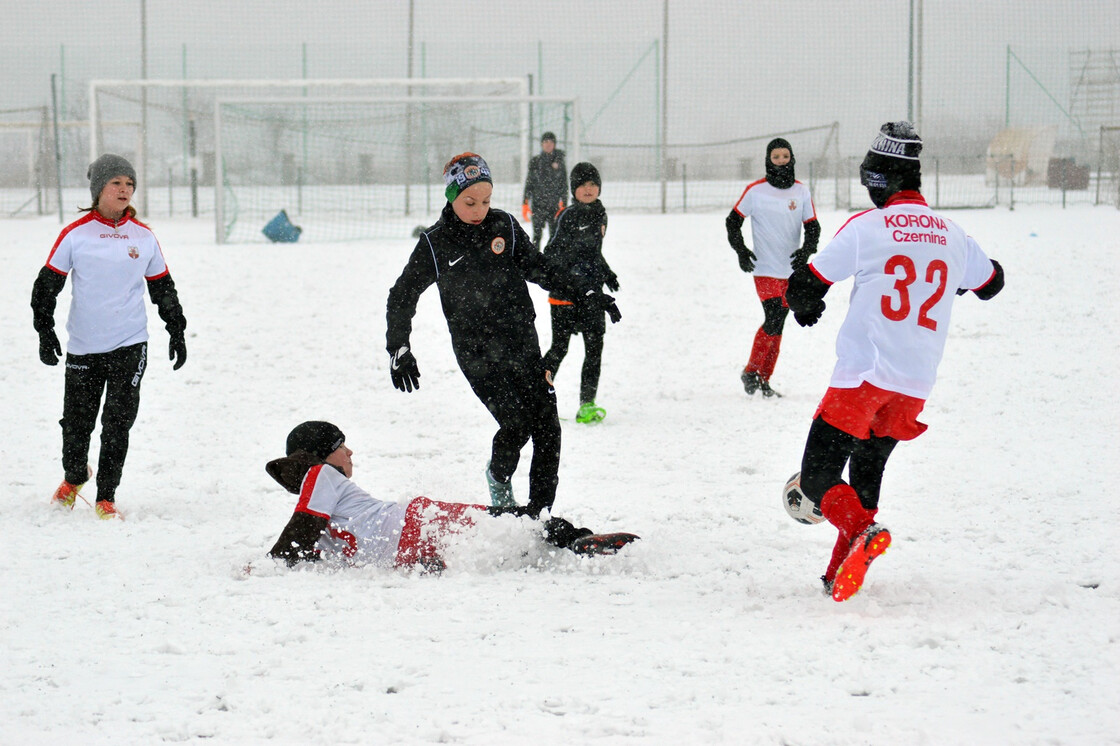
296, 464, 405, 567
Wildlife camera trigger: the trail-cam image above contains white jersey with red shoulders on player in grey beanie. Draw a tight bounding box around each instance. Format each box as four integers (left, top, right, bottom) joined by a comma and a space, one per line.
47, 209, 167, 355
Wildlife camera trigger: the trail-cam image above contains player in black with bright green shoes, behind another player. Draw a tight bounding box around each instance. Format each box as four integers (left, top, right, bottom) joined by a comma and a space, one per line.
544, 164, 618, 423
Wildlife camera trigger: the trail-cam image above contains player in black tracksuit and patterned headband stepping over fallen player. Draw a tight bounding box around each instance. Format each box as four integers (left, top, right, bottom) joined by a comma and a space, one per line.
385, 152, 622, 516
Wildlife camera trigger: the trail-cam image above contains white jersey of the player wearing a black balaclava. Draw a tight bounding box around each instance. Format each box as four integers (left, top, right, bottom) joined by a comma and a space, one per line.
735, 179, 816, 280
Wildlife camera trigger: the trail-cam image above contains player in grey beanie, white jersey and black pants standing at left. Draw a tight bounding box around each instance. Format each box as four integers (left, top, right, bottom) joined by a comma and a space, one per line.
31, 153, 187, 519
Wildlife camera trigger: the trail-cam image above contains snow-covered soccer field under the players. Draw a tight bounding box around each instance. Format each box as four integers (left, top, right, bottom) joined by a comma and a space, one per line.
0, 204, 1120, 746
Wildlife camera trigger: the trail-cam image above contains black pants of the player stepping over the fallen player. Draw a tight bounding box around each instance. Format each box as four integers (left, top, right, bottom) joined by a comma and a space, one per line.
464, 360, 560, 517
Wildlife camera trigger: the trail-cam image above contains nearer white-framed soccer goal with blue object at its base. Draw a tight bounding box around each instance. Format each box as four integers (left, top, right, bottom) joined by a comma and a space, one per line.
214, 95, 579, 243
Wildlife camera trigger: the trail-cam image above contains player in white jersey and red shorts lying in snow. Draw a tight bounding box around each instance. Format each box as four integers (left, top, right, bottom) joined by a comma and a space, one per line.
265, 421, 638, 569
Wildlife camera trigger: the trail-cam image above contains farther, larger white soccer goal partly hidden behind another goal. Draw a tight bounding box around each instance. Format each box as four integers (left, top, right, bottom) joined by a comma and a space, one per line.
83, 77, 529, 215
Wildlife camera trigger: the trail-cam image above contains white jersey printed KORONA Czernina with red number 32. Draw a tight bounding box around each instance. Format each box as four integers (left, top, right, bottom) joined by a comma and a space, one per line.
809, 192, 995, 399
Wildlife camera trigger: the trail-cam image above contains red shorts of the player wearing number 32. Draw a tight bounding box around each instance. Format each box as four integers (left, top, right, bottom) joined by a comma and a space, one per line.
813, 382, 928, 440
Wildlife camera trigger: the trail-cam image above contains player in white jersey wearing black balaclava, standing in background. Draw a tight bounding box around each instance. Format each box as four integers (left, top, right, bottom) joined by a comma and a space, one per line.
725, 138, 821, 397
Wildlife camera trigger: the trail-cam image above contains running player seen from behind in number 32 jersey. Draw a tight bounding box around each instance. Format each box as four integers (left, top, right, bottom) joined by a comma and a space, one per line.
786, 122, 1004, 602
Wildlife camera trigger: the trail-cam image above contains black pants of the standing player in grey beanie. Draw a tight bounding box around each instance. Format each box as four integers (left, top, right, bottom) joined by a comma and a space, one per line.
58, 342, 148, 501
